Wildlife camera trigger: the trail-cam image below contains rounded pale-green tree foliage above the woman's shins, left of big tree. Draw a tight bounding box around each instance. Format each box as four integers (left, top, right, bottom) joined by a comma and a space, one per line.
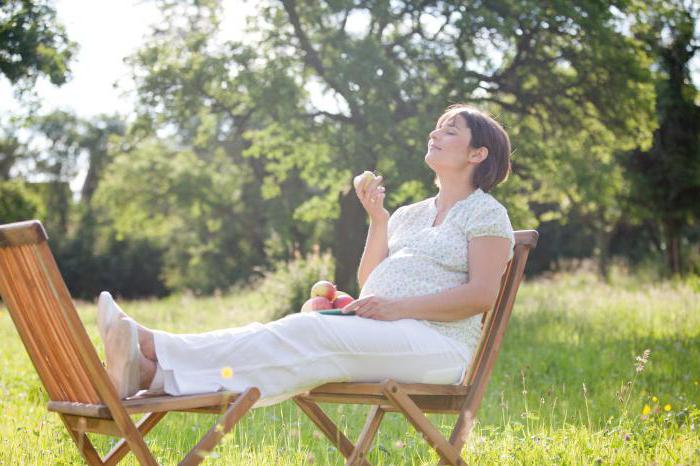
94, 141, 256, 293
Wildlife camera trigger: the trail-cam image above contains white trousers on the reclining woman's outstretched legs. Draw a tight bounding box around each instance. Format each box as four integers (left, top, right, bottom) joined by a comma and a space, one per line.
151, 312, 472, 408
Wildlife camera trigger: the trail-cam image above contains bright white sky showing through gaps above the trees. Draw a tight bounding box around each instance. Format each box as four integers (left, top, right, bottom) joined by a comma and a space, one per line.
0, 0, 700, 122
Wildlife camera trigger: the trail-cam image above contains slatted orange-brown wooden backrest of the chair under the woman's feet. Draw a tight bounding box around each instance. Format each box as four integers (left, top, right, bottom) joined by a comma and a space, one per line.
0, 220, 118, 404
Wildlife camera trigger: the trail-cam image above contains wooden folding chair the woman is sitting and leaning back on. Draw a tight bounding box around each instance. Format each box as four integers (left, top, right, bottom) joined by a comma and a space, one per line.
294, 230, 539, 466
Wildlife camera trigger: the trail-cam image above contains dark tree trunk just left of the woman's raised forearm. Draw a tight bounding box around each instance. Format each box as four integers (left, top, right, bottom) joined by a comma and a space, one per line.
332, 189, 368, 298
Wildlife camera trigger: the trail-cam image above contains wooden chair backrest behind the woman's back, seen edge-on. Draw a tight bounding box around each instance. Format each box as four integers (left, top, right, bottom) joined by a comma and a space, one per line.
462, 230, 539, 394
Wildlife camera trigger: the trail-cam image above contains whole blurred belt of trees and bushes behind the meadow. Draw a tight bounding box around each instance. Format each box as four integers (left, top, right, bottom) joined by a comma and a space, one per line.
0, 0, 700, 302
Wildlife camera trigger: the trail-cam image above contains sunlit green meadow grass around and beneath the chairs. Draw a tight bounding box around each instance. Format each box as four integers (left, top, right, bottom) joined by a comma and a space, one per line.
0, 272, 700, 465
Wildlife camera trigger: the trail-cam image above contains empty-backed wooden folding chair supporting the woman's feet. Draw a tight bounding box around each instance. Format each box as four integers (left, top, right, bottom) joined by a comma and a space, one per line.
0, 220, 260, 465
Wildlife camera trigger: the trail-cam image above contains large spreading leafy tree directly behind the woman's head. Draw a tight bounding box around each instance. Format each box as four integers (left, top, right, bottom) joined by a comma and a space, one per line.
132, 0, 653, 291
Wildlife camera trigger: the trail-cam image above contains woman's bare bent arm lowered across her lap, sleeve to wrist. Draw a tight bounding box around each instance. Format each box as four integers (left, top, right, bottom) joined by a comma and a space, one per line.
397, 236, 510, 322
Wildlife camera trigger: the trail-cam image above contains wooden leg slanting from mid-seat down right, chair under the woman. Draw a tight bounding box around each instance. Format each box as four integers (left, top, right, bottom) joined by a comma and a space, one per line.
384, 380, 466, 466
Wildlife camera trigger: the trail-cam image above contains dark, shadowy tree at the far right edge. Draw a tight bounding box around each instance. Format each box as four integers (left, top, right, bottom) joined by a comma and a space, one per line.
621, 1, 700, 274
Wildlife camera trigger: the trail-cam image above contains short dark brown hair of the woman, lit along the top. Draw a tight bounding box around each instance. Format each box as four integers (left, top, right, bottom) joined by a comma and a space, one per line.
435, 104, 511, 192
